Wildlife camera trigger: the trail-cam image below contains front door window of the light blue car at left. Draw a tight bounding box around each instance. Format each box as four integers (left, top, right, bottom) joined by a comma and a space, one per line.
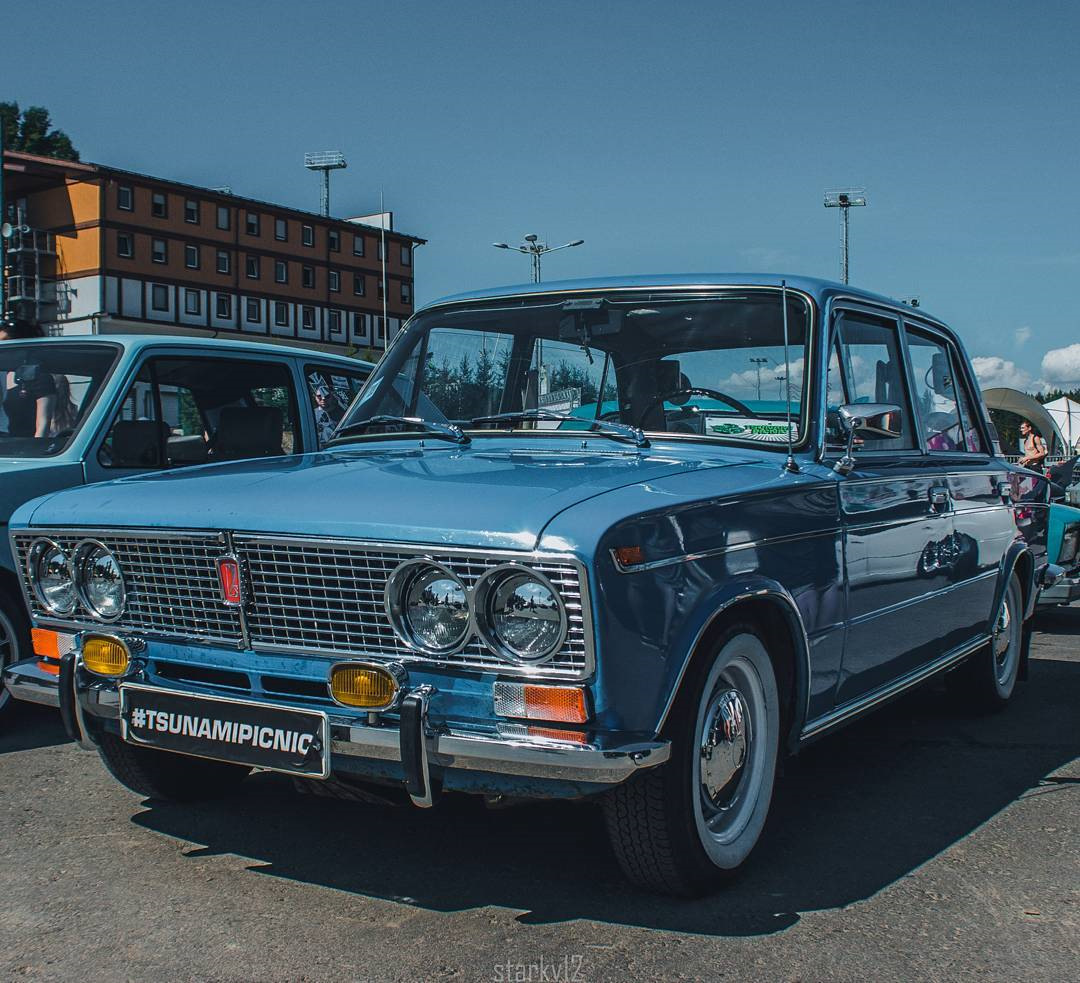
98, 355, 300, 470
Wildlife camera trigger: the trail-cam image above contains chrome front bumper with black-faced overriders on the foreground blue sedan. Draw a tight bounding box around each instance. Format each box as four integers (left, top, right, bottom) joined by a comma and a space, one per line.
57, 633, 671, 807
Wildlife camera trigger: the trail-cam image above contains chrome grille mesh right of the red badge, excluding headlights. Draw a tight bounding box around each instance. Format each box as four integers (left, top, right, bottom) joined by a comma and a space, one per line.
233, 536, 589, 675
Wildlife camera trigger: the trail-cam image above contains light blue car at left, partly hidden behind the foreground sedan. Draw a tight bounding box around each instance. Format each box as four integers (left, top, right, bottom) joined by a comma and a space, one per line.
0, 335, 372, 714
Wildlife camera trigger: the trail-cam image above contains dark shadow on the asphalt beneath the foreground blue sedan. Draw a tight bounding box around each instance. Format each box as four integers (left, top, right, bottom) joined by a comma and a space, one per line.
133, 659, 1080, 935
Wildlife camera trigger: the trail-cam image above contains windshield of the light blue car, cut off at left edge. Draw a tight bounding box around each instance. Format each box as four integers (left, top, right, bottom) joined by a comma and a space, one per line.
0, 341, 120, 457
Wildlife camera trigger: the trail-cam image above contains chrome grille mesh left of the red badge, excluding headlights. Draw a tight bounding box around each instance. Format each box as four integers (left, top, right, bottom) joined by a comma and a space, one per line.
13, 529, 241, 644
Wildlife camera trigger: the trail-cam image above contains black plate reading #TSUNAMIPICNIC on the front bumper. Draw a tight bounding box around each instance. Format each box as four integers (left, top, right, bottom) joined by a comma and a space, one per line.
120, 683, 329, 778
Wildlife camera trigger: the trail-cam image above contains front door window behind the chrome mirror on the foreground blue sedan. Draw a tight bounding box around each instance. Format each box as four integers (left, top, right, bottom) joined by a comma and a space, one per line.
826, 312, 915, 450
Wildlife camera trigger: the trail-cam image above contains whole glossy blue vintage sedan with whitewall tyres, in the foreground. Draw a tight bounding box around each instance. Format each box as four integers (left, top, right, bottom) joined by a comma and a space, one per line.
12, 275, 1055, 893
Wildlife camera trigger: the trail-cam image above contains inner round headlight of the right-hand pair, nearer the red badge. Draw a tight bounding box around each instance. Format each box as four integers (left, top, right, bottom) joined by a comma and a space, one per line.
387, 560, 471, 656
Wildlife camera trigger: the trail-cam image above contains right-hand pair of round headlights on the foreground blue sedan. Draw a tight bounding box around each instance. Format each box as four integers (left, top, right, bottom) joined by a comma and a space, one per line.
386, 560, 566, 664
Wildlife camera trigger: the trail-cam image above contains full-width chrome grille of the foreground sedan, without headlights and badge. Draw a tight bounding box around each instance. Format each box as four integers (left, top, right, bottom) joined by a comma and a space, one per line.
13, 529, 592, 678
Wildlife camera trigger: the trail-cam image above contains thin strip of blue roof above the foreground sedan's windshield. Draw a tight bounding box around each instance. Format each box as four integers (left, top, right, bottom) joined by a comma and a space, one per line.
423, 273, 937, 321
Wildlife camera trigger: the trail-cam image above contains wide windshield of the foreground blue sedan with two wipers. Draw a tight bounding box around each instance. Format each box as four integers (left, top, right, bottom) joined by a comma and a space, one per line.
338, 289, 810, 445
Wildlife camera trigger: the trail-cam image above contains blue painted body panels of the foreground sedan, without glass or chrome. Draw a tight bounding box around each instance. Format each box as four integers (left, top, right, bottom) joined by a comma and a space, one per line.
13, 274, 1045, 794
